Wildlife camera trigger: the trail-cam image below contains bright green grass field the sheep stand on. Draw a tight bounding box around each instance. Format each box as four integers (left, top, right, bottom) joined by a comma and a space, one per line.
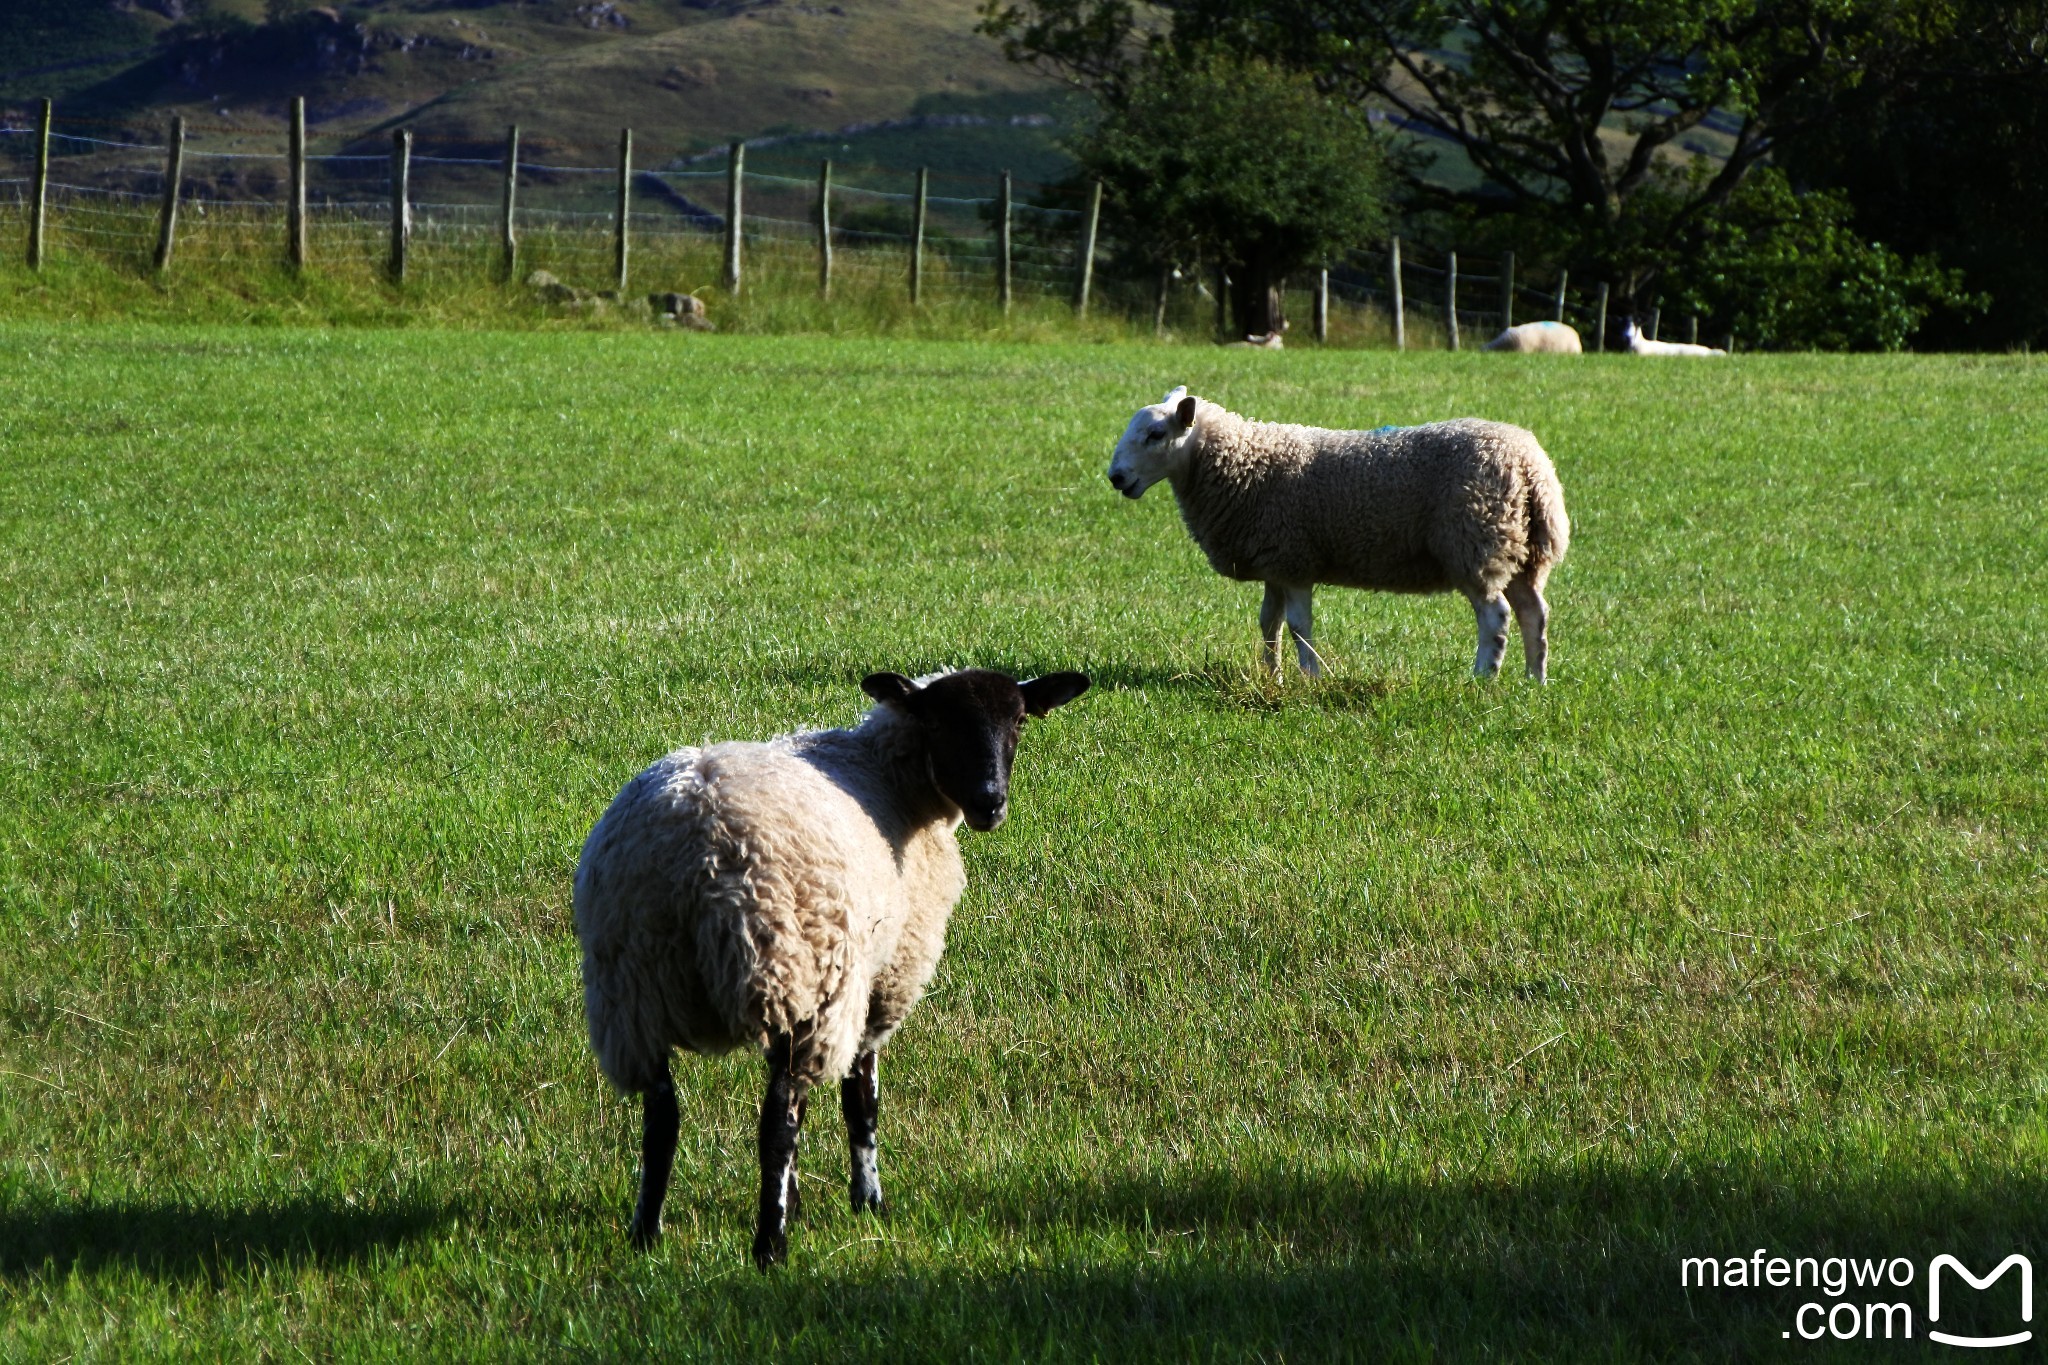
0, 323, 2048, 1361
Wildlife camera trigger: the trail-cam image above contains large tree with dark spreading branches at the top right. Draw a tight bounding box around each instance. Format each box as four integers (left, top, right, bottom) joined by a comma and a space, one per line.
983, 0, 1948, 295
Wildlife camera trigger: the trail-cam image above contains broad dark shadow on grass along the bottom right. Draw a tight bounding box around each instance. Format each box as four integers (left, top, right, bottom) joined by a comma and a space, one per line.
692, 1166, 2048, 1361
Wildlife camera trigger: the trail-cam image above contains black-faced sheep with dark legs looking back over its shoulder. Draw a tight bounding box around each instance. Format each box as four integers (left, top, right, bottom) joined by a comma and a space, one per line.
575, 669, 1087, 1269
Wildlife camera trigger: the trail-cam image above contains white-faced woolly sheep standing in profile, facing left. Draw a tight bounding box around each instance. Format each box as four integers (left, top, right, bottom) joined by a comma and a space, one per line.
1110, 389, 1571, 681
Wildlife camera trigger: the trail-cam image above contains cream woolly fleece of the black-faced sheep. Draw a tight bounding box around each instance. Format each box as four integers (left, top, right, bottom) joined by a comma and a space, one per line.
575, 706, 967, 1091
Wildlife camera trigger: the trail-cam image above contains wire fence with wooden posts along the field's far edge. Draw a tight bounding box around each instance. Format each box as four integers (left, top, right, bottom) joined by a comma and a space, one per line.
0, 106, 1698, 350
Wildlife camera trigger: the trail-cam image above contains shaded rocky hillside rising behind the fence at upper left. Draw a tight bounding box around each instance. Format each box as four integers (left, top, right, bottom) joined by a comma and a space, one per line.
0, 0, 1065, 178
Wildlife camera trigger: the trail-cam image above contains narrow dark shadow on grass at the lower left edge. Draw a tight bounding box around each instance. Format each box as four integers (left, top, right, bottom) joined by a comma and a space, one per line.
0, 1199, 453, 1279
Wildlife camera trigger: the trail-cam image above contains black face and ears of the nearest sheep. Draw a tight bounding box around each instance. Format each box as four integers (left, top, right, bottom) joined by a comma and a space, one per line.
860, 669, 1087, 831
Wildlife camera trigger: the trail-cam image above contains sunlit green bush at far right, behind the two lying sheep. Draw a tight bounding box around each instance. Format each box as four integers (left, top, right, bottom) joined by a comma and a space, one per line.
1665, 168, 1985, 350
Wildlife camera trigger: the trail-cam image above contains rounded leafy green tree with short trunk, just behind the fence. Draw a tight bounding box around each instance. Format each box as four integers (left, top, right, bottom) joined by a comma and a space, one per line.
1073, 55, 1386, 336
